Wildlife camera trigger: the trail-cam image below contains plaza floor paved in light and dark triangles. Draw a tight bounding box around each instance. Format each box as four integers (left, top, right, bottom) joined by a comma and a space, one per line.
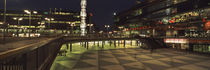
51, 43, 210, 70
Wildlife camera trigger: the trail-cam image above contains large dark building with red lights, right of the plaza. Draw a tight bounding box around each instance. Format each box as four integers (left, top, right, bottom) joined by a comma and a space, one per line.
114, 0, 210, 51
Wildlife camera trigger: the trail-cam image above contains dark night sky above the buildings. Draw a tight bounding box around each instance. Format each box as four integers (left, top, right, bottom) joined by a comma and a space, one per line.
0, 0, 135, 26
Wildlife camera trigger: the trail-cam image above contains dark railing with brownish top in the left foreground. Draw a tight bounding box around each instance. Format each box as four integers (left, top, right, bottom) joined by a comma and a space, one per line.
0, 36, 62, 70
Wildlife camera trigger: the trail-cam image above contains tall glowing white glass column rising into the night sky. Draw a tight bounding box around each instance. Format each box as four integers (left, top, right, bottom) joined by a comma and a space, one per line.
80, 0, 87, 36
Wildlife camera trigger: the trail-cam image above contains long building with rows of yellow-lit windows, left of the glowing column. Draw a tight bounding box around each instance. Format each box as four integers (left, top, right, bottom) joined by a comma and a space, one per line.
0, 9, 89, 34
